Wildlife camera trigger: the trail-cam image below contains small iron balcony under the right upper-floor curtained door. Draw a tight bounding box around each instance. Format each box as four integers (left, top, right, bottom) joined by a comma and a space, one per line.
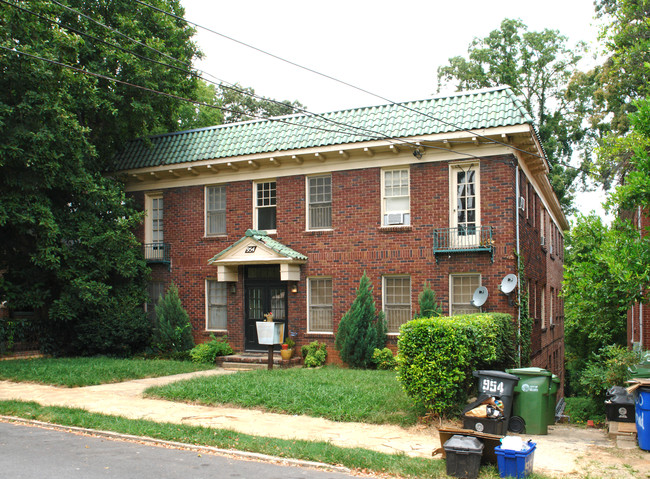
433, 226, 494, 263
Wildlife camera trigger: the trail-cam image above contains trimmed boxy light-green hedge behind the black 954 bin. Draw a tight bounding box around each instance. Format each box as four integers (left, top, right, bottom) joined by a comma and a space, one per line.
397, 313, 515, 414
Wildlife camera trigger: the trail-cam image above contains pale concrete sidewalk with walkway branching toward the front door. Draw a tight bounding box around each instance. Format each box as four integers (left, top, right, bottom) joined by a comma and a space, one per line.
0, 369, 634, 477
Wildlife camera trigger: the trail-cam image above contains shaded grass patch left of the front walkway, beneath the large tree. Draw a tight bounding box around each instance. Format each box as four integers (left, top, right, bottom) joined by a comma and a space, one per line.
0, 357, 214, 387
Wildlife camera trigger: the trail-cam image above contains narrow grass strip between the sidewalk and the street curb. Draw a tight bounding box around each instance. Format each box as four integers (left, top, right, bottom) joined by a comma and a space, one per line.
0, 401, 512, 479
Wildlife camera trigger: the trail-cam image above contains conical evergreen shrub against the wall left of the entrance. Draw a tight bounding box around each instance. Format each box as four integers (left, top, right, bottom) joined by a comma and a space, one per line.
153, 283, 194, 352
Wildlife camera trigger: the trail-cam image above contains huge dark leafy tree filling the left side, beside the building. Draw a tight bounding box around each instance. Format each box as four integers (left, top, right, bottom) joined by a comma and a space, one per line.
0, 0, 198, 354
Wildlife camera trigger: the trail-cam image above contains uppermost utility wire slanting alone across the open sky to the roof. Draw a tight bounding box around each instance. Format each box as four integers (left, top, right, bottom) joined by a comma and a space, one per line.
134, 0, 545, 163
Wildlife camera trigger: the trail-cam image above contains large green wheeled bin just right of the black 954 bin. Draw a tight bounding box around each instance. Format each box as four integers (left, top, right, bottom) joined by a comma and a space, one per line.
506, 368, 557, 434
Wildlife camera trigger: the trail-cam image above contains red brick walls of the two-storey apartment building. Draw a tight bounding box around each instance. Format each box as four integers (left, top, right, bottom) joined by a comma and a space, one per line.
132, 154, 564, 384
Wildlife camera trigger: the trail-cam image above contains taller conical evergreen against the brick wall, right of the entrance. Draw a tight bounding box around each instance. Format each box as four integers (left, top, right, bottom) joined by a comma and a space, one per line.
335, 272, 386, 369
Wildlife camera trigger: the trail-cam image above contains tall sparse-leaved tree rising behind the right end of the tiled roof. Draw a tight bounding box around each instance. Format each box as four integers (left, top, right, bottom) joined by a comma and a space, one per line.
438, 19, 585, 207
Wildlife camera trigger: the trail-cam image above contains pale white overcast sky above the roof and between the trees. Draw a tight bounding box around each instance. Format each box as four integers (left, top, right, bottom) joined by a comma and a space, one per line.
181, 0, 602, 221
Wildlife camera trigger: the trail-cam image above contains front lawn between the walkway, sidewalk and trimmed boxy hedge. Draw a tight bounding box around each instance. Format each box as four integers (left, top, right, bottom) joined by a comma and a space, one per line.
145, 366, 425, 426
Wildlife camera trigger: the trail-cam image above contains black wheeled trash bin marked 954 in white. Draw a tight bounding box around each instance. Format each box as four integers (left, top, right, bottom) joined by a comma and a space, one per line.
463, 369, 519, 436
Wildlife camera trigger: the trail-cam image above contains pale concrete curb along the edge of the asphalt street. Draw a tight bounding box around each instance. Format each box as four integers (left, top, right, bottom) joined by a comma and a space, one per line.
0, 415, 351, 474
